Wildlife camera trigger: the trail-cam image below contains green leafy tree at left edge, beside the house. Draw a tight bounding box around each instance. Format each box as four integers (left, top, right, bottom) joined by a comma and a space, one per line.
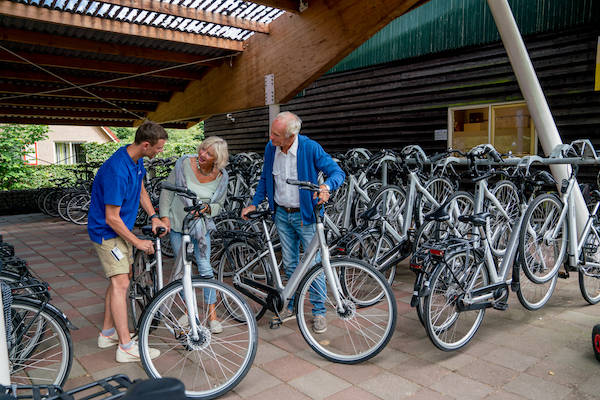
0, 124, 48, 190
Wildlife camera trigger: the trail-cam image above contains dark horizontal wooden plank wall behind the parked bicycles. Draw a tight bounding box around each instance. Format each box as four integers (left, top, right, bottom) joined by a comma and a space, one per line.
205, 25, 600, 158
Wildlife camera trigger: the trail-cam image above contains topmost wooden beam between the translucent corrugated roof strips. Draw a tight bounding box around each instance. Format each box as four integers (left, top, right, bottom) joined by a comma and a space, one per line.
100, 0, 269, 33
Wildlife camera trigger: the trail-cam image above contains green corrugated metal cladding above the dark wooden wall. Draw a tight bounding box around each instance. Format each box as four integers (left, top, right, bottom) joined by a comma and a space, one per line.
329, 0, 600, 73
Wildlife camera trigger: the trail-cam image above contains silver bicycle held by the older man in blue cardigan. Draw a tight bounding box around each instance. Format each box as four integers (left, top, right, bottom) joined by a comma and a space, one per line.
219, 179, 397, 364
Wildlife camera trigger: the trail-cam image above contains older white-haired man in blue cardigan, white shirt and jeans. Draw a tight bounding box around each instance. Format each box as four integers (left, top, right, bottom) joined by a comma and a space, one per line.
242, 112, 346, 333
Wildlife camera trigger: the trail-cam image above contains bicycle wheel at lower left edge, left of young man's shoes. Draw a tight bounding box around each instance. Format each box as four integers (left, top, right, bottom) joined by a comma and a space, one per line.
9, 299, 73, 386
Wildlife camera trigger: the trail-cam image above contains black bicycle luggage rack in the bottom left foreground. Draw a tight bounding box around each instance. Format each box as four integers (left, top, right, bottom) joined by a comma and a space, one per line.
0, 374, 134, 400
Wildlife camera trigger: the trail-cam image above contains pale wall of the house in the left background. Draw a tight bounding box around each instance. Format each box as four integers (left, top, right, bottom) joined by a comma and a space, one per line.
37, 125, 111, 165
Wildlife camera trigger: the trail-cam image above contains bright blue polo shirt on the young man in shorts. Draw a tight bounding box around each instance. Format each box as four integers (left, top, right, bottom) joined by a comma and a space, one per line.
88, 146, 146, 244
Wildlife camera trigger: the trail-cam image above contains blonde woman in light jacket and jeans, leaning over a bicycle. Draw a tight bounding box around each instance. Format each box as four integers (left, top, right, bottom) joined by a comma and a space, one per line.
159, 136, 229, 333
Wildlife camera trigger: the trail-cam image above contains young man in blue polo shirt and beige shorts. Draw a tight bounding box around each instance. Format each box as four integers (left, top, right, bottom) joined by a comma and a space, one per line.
88, 122, 168, 362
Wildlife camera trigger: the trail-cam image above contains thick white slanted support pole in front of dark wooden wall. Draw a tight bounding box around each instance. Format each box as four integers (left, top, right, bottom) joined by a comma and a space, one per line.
487, 0, 589, 234
